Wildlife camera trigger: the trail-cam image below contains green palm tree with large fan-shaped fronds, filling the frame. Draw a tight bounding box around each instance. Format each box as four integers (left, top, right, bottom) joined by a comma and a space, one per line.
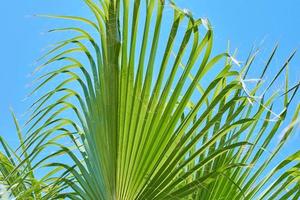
0, 0, 300, 200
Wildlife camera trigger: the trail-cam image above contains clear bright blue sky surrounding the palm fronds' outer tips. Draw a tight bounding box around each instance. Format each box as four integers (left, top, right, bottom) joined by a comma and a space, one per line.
0, 0, 300, 160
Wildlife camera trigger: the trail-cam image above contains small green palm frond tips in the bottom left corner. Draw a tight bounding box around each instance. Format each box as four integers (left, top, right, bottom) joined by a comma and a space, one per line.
0, 113, 65, 200
